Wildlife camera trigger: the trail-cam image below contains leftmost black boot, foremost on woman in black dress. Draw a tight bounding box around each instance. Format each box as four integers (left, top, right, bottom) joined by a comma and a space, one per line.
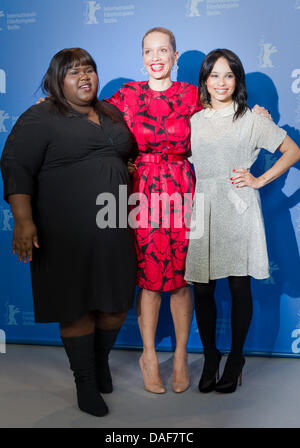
61, 333, 108, 417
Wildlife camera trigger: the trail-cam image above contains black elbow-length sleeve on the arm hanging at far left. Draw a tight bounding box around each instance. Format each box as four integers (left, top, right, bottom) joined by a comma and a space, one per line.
1, 106, 48, 201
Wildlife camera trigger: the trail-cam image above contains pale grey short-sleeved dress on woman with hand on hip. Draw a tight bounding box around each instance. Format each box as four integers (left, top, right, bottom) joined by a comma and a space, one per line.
185, 103, 286, 283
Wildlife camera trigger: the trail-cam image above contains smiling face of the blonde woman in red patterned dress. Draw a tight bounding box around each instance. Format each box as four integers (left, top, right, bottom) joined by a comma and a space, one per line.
143, 31, 178, 81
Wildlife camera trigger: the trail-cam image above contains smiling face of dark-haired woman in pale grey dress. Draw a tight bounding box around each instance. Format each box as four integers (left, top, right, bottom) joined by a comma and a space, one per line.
205, 57, 236, 109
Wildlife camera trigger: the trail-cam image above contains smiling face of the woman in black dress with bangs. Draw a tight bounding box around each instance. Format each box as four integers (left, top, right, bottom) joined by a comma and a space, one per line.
62, 65, 98, 110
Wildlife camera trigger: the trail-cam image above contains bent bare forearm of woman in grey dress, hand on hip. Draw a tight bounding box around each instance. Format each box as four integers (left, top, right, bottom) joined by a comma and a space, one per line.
258, 137, 300, 187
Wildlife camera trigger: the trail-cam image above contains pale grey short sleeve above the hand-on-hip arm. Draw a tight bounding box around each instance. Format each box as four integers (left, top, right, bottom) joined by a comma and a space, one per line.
252, 112, 287, 153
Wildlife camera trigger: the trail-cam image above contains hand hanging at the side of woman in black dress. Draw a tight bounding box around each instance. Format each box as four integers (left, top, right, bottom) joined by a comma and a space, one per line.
12, 220, 39, 263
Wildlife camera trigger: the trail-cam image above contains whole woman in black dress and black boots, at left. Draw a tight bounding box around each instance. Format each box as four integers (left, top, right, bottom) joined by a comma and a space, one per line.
1, 48, 136, 416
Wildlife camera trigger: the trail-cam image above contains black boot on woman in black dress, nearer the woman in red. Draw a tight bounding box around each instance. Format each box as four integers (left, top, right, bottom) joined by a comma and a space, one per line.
95, 328, 120, 394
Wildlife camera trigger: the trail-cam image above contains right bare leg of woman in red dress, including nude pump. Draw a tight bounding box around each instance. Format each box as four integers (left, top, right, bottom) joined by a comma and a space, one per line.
170, 287, 193, 392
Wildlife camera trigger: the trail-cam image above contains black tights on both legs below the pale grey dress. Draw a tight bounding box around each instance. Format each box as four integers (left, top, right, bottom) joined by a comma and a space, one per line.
194, 277, 253, 357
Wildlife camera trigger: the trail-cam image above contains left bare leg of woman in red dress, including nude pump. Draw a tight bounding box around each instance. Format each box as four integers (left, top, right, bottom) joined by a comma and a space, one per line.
137, 289, 166, 394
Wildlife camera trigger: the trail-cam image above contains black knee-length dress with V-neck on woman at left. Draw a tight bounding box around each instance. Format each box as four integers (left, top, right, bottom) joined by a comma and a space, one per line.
1, 101, 136, 322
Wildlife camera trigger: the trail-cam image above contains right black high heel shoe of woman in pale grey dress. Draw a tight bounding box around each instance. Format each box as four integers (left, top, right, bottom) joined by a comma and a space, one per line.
215, 355, 246, 394
